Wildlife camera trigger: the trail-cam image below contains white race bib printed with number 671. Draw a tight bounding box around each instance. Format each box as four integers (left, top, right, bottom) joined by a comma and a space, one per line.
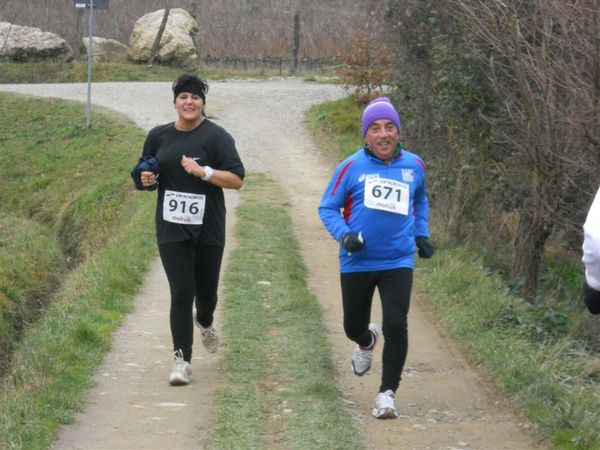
364, 176, 410, 216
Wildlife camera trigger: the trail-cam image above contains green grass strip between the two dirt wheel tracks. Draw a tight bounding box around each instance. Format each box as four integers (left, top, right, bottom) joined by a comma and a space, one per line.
209, 174, 363, 449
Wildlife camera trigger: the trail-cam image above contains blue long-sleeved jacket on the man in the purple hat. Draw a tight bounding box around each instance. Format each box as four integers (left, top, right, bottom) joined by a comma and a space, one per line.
319, 148, 429, 272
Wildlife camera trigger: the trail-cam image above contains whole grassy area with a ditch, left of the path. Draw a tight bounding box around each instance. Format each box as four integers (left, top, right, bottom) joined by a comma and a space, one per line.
0, 94, 156, 449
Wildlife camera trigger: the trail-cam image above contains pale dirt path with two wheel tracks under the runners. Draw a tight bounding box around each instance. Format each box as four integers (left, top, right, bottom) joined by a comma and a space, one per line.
0, 80, 542, 450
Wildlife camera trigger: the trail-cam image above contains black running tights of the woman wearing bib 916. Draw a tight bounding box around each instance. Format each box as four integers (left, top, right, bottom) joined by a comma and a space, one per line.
158, 241, 223, 361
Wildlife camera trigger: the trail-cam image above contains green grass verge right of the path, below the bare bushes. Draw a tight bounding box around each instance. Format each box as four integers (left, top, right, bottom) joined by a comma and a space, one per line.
415, 248, 600, 449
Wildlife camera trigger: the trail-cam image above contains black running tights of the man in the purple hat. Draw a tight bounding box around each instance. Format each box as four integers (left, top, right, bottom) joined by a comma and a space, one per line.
341, 269, 413, 392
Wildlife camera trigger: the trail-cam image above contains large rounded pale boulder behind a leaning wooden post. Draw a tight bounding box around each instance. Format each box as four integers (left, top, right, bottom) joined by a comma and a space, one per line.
129, 8, 198, 69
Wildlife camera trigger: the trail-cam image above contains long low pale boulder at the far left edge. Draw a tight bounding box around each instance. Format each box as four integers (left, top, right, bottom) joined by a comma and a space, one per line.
0, 22, 73, 62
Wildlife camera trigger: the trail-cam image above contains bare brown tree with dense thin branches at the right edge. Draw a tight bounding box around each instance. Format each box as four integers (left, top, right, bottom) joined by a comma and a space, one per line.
454, 0, 599, 298
